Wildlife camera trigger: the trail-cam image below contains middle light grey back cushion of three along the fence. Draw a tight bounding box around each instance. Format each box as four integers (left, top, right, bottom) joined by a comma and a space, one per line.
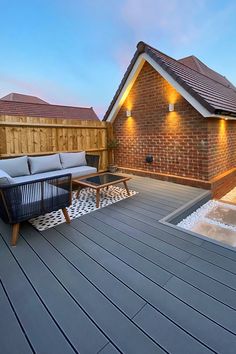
29, 154, 62, 175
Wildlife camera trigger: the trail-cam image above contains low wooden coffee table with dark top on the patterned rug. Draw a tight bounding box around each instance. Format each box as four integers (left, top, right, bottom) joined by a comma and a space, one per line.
73, 173, 130, 208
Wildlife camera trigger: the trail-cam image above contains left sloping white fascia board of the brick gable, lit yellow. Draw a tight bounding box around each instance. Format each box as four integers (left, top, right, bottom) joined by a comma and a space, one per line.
106, 55, 145, 122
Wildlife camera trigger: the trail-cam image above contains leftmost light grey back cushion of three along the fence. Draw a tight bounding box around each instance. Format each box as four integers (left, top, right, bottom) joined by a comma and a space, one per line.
0, 156, 30, 177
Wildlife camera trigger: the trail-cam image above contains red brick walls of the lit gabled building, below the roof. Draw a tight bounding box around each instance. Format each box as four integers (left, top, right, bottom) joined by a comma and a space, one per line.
114, 63, 236, 181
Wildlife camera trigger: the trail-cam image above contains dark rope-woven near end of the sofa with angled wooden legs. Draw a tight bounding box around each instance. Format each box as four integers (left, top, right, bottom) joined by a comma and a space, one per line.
0, 174, 72, 246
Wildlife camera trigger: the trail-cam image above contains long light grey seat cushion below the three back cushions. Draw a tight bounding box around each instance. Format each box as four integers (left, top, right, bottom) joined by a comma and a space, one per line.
14, 166, 97, 183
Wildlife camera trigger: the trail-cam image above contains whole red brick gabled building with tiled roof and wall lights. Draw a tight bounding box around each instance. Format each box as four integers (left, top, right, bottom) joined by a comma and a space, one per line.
104, 42, 236, 195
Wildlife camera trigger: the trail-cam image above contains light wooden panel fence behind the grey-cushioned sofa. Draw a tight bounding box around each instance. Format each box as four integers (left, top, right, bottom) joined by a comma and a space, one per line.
0, 115, 112, 171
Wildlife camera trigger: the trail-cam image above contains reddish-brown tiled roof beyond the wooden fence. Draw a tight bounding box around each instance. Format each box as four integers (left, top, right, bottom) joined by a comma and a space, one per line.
0, 94, 99, 120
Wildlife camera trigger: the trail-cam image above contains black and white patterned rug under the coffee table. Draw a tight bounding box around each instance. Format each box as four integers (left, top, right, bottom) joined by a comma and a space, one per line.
29, 186, 138, 231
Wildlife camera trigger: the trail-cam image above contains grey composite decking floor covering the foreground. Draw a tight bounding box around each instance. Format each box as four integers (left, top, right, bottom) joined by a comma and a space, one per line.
0, 177, 236, 354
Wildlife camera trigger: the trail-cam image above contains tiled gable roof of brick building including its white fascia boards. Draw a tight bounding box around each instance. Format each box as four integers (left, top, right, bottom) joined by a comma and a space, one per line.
103, 42, 236, 121
